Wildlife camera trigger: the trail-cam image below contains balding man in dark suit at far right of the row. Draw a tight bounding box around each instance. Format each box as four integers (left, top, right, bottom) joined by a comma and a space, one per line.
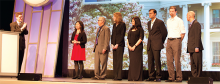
187, 11, 203, 77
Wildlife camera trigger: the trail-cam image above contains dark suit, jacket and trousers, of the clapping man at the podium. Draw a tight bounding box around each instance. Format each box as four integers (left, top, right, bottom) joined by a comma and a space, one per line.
10, 22, 28, 73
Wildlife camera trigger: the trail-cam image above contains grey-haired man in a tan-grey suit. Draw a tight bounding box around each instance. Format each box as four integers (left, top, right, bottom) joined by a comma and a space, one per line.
92, 17, 110, 80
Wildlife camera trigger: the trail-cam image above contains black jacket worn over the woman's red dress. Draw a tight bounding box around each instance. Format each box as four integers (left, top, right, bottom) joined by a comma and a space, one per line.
70, 32, 87, 48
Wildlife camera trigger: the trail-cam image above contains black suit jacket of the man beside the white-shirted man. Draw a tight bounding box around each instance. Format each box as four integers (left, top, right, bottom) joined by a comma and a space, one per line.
147, 18, 167, 50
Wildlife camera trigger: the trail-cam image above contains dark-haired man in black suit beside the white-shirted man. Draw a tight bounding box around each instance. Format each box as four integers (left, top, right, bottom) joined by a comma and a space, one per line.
146, 9, 167, 82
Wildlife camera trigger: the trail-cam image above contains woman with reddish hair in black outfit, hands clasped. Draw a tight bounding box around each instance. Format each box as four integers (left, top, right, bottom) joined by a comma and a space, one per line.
111, 12, 126, 80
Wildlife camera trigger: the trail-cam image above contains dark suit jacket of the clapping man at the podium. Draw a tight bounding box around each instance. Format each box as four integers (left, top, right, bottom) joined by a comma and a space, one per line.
10, 22, 28, 50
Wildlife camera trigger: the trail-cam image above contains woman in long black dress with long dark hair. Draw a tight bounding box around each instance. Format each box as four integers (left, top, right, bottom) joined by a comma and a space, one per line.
127, 17, 144, 81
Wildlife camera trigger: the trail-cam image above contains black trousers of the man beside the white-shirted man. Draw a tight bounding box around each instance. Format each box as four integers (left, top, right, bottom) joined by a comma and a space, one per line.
147, 47, 162, 79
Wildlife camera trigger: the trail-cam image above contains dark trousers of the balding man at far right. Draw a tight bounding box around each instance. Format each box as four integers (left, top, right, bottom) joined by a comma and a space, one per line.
190, 51, 202, 77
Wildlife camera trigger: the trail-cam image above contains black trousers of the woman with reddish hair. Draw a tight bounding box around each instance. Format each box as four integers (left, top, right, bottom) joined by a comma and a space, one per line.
113, 46, 124, 79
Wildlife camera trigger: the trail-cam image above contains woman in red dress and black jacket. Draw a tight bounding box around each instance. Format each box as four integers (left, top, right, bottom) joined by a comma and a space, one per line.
70, 21, 87, 79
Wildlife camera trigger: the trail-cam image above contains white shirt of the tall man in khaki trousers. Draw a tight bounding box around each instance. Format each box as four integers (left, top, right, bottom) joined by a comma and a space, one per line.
167, 16, 186, 38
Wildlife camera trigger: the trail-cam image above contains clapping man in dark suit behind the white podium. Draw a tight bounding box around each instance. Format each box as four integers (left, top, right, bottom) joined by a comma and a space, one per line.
10, 12, 28, 73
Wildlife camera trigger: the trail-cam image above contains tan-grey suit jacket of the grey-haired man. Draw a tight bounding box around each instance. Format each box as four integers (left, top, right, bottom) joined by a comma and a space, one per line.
93, 25, 110, 53
